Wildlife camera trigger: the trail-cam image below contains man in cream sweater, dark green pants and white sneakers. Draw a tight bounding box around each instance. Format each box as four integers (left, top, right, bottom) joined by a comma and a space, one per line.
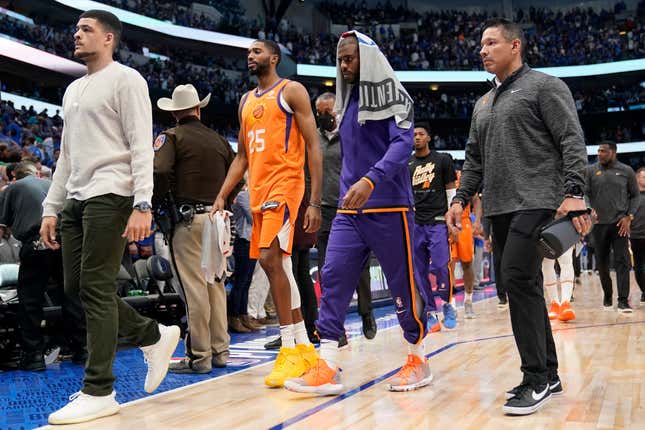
40, 10, 179, 424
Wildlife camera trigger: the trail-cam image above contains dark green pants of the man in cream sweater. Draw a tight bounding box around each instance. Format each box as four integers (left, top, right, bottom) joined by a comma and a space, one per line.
61, 194, 160, 396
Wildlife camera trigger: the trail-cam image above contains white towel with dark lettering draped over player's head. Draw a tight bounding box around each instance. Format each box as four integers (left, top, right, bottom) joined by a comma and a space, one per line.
334, 30, 414, 129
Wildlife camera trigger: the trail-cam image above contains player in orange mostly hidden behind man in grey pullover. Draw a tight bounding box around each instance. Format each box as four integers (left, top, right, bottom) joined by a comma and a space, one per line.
450, 170, 481, 319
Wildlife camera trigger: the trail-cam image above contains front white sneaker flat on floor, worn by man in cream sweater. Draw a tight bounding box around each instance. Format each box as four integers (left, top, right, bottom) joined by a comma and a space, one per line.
47, 391, 120, 424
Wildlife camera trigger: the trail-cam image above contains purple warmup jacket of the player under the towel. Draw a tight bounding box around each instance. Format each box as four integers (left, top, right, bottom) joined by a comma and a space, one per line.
338, 87, 414, 209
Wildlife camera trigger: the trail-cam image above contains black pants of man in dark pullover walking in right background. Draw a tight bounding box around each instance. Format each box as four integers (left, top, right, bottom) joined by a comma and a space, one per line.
591, 223, 630, 302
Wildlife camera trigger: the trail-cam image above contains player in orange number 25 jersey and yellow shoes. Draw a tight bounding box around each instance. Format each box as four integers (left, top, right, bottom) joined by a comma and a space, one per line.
211, 40, 322, 387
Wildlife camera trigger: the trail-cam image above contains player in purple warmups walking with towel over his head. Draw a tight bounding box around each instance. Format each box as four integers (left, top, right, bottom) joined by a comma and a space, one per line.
285, 31, 432, 395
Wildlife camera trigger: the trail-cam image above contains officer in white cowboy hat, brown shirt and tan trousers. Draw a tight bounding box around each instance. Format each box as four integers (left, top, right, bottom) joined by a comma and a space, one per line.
153, 84, 235, 373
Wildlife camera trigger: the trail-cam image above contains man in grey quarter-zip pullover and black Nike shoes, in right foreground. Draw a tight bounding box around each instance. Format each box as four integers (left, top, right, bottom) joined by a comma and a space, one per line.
446, 19, 591, 415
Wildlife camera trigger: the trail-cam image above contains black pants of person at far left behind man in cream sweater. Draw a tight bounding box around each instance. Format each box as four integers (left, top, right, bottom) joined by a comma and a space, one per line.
18, 241, 86, 355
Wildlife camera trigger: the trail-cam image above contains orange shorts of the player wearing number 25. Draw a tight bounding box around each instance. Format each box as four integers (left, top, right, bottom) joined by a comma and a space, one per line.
249, 203, 294, 260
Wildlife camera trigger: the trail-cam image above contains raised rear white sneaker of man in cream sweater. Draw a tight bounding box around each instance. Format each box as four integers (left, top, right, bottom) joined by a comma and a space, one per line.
141, 324, 181, 393
